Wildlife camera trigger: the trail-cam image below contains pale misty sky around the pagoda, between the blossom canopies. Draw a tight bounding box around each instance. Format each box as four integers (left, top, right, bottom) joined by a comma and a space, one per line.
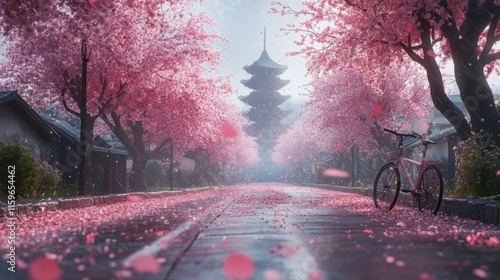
199, 0, 310, 107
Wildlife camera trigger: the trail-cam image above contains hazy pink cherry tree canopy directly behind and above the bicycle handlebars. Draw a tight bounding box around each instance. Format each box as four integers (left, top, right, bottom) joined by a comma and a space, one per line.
306, 67, 429, 153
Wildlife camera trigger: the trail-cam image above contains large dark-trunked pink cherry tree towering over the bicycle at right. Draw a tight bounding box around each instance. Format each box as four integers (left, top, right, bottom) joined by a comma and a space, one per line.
273, 0, 500, 145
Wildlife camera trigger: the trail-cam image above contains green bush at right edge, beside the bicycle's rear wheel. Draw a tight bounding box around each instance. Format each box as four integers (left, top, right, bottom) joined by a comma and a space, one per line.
454, 134, 500, 196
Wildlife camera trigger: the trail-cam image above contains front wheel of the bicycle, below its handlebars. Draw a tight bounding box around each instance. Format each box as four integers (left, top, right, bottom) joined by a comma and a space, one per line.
373, 163, 401, 210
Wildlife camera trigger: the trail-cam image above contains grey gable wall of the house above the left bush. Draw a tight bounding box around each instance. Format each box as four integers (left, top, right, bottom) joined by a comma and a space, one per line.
0, 103, 52, 163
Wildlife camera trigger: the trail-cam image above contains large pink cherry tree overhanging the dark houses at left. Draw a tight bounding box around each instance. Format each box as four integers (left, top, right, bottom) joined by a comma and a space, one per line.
0, 0, 237, 192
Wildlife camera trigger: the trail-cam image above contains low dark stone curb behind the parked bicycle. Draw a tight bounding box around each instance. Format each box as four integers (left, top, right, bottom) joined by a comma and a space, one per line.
308, 184, 500, 225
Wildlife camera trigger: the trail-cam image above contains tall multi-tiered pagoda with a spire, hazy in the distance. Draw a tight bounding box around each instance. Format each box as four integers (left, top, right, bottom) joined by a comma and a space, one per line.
240, 28, 290, 178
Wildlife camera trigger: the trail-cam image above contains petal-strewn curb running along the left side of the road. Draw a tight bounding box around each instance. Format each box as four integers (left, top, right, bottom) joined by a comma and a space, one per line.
0, 186, 215, 219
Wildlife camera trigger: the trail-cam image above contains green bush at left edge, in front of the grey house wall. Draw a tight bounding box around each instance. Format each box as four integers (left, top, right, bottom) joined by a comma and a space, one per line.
0, 141, 60, 201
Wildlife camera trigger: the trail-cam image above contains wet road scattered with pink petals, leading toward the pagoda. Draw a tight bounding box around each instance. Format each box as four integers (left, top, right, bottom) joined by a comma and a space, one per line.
0, 184, 500, 280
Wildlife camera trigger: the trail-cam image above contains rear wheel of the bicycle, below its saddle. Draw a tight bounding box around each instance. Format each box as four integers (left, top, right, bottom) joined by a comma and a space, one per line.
417, 165, 443, 215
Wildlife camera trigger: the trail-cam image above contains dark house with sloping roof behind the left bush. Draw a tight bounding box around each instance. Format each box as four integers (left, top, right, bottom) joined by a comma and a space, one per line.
0, 91, 127, 194
